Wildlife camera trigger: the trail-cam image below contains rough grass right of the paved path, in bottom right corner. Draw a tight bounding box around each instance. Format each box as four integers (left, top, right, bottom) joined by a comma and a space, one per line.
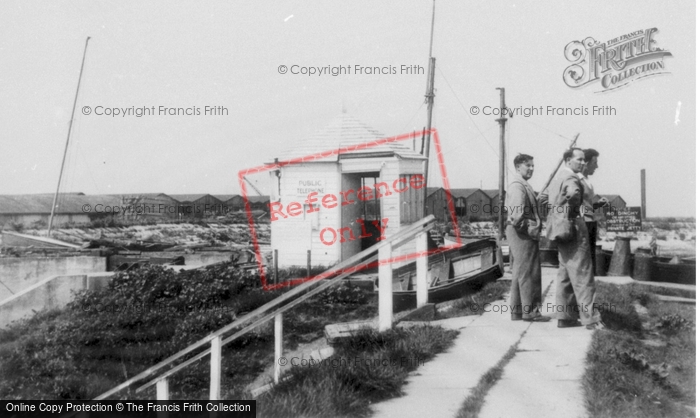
583, 283, 696, 417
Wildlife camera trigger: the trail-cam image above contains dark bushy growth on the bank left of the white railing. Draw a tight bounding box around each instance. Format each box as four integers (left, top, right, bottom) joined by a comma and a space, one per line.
0, 263, 279, 399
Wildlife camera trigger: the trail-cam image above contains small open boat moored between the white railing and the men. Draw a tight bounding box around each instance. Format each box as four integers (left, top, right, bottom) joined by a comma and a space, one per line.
382, 238, 503, 312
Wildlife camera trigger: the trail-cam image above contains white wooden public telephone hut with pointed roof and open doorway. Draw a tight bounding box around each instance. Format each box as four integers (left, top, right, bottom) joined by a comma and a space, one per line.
269, 113, 426, 267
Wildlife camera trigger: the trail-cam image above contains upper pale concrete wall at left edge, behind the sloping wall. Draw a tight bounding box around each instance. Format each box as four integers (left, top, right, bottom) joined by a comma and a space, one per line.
0, 256, 107, 301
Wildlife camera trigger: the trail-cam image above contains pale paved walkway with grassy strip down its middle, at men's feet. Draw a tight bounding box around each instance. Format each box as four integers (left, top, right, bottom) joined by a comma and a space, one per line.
373, 268, 592, 418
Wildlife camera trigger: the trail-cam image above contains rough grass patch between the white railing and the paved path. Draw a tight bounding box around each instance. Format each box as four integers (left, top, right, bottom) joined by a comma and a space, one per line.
257, 326, 458, 417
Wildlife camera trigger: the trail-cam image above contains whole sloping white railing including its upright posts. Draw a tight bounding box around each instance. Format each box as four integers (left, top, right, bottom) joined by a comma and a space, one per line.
95, 215, 435, 400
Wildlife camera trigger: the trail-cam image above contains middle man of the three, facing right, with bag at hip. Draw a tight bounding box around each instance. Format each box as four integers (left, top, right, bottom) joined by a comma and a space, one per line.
543, 148, 603, 330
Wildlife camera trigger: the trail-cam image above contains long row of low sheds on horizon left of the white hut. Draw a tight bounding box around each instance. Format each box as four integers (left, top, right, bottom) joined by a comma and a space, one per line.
0, 193, 270, 226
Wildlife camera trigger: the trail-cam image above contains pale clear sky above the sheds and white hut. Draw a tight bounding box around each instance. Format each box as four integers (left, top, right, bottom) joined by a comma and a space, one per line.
0, 0, 697, 216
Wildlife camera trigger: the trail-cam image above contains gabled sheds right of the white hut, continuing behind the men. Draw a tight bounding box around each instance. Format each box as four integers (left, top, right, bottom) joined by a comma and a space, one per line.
426, 187, 627, 221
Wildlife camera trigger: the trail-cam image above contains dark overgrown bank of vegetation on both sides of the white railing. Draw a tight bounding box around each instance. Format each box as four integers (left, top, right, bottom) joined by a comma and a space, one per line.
0, 264, 377, 399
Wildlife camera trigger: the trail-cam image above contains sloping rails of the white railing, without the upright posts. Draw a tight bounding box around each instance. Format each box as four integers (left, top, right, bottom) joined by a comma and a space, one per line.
95, 215, 436, 400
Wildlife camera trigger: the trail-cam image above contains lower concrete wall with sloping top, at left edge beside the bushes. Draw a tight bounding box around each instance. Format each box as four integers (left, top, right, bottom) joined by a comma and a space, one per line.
0, 273, 114, 328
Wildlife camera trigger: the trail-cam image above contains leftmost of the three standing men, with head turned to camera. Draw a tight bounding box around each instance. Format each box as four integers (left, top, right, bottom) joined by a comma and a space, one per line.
506, 154, 551, 322
